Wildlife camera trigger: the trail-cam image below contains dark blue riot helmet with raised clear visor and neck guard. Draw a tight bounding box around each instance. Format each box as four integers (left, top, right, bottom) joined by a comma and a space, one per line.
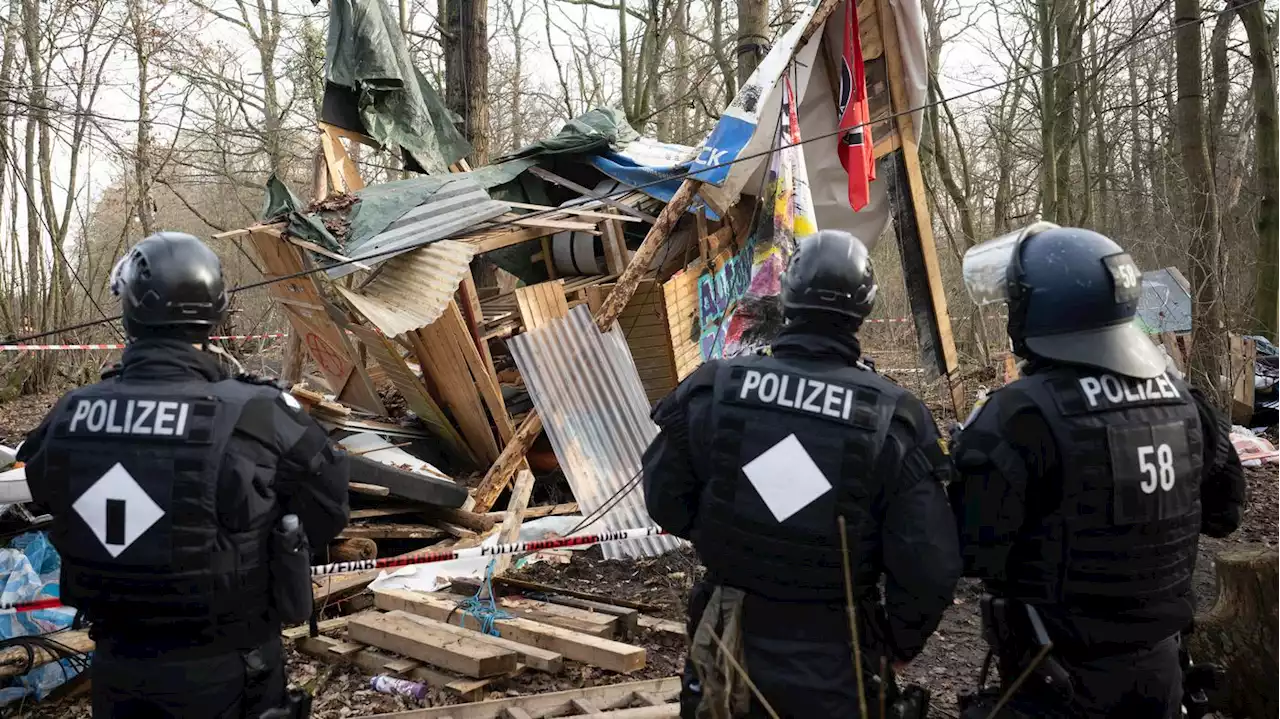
964, 223, 1165, 379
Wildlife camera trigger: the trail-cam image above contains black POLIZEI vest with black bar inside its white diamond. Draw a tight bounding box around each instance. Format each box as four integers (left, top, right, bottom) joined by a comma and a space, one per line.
44, 380, 278, 646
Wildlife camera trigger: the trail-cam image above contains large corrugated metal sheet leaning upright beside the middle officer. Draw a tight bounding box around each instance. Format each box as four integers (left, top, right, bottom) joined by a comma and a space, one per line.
511, 304, 682, 559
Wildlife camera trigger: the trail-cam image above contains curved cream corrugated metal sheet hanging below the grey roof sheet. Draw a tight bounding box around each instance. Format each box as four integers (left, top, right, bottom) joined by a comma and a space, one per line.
338, 239, 476, 336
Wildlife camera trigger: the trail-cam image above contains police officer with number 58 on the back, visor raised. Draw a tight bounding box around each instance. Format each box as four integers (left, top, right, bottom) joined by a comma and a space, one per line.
950, 223, 1244, 719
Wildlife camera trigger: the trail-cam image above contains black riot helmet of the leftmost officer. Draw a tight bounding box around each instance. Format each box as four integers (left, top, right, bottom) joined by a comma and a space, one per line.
111, 232, 228, 342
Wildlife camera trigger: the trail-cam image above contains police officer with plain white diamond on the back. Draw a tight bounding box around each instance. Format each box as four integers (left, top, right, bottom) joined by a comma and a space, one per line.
644, 230, 960, 719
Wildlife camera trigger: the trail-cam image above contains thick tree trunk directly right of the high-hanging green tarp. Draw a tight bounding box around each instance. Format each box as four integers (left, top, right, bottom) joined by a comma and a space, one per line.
442, 0, 489, 168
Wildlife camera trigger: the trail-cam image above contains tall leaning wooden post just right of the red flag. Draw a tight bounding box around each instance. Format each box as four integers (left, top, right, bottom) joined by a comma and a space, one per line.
876, 0, 966, 416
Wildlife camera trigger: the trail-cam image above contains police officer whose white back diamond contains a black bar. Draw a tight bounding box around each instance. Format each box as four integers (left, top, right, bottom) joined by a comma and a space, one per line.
19, 233, 348, 719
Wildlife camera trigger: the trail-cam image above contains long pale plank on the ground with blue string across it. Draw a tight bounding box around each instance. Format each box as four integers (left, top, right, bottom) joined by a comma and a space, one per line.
374, 590, 645, 674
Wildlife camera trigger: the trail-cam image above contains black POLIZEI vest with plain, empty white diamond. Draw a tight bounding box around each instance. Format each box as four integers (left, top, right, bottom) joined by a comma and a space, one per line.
695, 357, 902, 601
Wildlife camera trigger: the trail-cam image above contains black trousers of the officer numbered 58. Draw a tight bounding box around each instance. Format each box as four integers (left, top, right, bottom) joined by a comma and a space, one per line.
964, 637, 1183, 719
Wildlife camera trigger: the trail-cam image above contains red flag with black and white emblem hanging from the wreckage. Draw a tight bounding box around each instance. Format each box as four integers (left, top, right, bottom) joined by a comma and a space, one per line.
837, 0, 876, 212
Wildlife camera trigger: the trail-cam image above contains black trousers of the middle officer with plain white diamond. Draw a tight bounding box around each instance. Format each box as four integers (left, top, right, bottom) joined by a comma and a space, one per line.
680, 582, 899, 719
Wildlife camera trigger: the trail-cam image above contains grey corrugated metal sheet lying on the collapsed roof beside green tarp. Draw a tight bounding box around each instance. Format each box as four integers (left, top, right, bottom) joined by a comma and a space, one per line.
328, 175, 511, 278
